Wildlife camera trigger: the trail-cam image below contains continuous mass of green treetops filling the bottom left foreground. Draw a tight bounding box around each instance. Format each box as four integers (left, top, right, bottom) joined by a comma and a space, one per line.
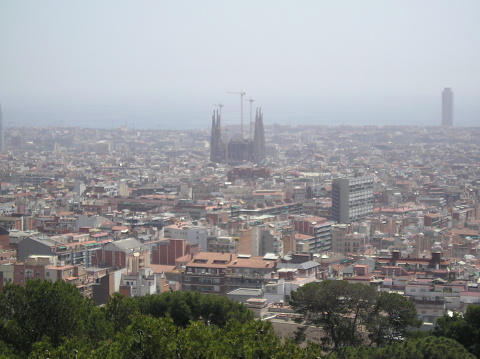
0, 281, 321, 359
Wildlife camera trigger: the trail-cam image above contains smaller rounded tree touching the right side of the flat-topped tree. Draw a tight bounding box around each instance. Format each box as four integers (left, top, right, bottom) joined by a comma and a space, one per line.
367, 293, 422, 346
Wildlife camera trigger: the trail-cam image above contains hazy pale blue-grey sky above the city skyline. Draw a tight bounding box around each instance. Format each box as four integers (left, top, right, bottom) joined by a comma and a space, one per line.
0, 0, 480, 129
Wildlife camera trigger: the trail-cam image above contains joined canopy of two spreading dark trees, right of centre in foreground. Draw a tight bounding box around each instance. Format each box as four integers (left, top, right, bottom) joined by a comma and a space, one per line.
290, 281, 421, 350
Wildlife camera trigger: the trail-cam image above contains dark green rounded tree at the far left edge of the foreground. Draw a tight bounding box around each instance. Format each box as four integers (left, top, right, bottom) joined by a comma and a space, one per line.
0, 280, 94, 353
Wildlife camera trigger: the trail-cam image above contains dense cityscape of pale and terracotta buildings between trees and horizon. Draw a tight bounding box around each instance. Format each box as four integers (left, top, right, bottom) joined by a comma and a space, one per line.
0, 93, 480, 348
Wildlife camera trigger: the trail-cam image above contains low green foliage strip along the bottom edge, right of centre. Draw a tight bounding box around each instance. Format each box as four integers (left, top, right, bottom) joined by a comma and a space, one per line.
326, 336, 475, 359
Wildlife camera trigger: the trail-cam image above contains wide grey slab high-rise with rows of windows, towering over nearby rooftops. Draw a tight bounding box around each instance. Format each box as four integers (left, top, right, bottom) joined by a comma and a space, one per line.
332, 176, 373, 223
